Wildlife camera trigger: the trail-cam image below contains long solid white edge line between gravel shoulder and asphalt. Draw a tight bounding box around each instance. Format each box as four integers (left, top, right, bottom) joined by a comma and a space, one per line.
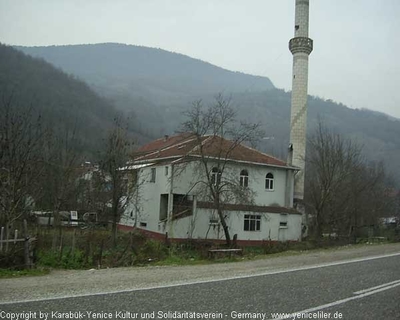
0, 252, 400, 305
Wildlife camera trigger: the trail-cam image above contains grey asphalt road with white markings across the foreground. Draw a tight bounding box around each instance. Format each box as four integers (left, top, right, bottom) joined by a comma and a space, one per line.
0, 253, 400, 320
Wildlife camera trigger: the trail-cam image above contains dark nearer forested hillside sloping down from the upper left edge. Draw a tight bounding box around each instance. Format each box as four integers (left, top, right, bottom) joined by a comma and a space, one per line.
0, 44, 151, 153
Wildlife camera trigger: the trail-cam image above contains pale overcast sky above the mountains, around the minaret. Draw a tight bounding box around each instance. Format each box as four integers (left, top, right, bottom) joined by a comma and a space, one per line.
0, 0, 400, 118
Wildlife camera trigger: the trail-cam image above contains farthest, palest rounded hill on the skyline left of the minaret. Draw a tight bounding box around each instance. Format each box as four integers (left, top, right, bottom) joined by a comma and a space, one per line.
17, 43, 274, 102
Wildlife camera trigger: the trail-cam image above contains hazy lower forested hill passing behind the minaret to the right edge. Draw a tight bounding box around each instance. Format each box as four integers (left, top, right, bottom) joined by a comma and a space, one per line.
233, 89, 400, 183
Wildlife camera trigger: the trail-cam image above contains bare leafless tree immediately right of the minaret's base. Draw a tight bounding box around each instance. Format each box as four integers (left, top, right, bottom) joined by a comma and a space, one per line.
305, 122, 394, 239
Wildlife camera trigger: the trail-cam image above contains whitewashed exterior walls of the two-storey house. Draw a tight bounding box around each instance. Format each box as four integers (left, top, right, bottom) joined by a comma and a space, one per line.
120, 163, 301, 241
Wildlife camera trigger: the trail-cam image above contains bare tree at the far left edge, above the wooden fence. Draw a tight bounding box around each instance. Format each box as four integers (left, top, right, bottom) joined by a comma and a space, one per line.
0, 95, 45, 241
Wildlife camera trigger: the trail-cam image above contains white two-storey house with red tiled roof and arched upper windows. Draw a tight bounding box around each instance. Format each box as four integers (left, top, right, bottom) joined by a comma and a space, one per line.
120, 134, 302, 245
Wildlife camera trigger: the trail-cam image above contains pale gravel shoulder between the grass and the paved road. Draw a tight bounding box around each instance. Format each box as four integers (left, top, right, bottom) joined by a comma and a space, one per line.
0, 243, 400, 304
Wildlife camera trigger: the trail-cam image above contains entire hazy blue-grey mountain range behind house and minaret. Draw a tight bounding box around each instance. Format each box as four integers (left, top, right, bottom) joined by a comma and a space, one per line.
17, 44, 400, 182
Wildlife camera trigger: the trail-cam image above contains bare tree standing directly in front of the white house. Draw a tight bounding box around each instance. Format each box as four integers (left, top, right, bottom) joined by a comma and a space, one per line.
182, 94, 261, 246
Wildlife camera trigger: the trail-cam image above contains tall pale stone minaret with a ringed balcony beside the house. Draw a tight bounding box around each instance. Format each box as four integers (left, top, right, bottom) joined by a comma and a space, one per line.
289, 0, 313, 202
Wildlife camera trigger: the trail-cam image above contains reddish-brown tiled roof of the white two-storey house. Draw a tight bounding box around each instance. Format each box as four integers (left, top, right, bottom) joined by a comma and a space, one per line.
133, 133, 288, 167
